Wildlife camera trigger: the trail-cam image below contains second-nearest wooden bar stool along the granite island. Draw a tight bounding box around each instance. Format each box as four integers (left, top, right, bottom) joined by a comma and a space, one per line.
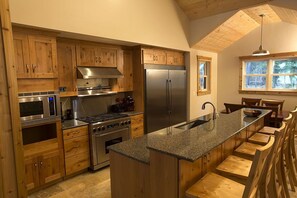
216, 126, 285, 197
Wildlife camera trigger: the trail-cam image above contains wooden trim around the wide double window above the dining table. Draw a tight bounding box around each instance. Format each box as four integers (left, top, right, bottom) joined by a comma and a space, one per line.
238, 52, 297, 95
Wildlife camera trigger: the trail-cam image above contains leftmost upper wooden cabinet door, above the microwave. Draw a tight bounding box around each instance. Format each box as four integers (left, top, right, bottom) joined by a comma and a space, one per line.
13, 32, 31, 78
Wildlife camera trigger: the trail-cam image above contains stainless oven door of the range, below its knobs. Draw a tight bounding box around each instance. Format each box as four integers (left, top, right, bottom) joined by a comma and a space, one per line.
94, 127, 130, 166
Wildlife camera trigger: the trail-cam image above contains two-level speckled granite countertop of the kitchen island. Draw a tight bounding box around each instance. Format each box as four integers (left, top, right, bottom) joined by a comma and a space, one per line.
109, 109, 270, 163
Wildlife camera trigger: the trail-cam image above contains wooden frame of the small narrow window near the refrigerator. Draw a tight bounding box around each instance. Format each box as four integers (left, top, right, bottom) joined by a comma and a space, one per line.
197, 56, 212, 95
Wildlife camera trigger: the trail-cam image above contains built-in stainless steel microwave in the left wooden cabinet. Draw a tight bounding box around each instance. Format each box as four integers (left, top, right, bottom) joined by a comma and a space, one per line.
19, 92, 61, 126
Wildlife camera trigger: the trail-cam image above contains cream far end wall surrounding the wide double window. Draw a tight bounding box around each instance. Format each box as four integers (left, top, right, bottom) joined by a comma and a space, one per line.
218, 22, 297, 110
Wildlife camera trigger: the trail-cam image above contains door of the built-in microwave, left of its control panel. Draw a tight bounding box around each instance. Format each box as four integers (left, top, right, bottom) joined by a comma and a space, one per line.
19, 96, 49, 122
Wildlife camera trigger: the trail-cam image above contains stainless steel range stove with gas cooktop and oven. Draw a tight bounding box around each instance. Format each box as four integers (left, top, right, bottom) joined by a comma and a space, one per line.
78, 113, 131, 170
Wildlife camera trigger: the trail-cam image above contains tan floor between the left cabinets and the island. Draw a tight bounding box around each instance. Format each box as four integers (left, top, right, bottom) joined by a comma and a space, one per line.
29, 140, 297, 198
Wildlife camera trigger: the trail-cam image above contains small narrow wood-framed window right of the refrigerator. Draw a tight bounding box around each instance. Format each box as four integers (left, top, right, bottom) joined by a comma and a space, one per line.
197, 56, 211, 95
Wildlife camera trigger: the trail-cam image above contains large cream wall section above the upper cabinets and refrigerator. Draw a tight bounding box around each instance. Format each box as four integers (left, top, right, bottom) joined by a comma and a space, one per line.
9, 0, 189, 50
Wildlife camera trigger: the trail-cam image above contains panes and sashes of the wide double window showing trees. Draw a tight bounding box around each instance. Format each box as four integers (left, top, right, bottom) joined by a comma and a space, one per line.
243, 58, 297, 91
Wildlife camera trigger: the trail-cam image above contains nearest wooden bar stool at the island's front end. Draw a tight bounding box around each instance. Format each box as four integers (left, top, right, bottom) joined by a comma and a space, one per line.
186, 137, 274, 198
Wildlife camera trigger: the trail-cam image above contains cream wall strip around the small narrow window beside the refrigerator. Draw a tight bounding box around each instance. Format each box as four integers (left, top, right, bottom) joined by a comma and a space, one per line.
188, 49, 217, 119
